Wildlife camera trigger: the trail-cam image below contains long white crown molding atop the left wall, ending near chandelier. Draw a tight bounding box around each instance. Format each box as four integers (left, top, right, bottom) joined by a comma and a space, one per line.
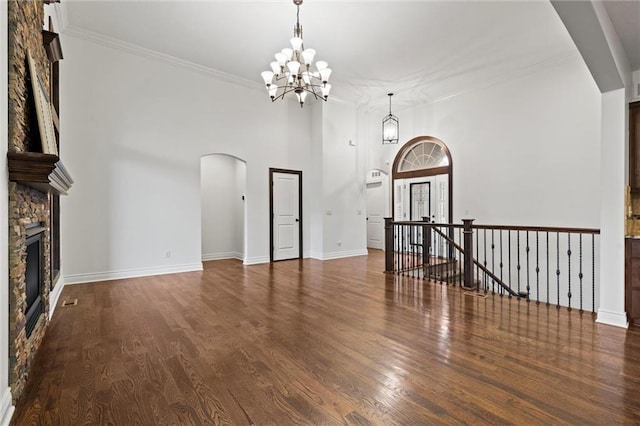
63, 25, 264, 92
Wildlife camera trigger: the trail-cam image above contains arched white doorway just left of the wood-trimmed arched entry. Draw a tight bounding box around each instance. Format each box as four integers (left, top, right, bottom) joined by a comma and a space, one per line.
366, 169, 390, 250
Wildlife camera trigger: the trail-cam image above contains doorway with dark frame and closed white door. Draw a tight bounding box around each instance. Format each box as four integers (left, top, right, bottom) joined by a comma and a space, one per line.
269, 168, 302, 262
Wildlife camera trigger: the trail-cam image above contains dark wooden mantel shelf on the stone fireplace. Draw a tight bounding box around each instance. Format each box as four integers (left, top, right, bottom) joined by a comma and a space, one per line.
7, 152, 73, 195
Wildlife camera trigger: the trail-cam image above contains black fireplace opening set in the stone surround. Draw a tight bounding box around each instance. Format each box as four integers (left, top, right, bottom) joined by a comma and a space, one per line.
25, 224, 44, 338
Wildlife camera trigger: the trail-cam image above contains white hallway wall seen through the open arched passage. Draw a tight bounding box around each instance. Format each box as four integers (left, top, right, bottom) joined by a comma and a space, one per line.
200, 155, 246, 260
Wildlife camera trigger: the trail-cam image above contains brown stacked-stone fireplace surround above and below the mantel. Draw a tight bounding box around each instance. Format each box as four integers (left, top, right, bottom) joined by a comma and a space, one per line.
4, 0, 52, 403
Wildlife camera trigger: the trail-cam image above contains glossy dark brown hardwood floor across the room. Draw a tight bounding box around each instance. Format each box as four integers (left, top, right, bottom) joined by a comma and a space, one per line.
12, 252, 640, 425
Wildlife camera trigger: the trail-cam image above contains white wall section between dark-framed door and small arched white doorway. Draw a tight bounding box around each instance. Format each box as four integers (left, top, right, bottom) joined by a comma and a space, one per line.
322, 101, 367, 259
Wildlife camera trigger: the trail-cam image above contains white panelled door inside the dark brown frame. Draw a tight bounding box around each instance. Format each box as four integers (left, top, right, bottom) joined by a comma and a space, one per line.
273, 172, 300, 260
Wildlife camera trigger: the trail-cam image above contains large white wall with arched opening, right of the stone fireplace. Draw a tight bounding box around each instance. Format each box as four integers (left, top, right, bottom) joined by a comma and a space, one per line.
61, 35, 310, 283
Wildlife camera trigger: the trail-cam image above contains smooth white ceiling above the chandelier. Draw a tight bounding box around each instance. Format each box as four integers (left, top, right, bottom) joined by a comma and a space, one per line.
63, 0, 637, 108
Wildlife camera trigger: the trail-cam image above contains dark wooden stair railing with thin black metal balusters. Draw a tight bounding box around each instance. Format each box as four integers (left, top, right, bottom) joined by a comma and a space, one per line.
385, 218, 600, 313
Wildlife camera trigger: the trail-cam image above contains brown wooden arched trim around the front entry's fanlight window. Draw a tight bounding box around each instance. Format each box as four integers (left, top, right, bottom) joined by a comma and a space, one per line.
391, 136, 453, 223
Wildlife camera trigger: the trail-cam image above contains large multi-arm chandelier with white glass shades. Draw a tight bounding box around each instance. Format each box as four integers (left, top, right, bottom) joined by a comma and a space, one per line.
262, 0, 331, 108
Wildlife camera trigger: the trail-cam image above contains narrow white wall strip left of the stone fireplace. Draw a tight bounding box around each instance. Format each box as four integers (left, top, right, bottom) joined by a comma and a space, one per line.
0, 0, 13, 425
